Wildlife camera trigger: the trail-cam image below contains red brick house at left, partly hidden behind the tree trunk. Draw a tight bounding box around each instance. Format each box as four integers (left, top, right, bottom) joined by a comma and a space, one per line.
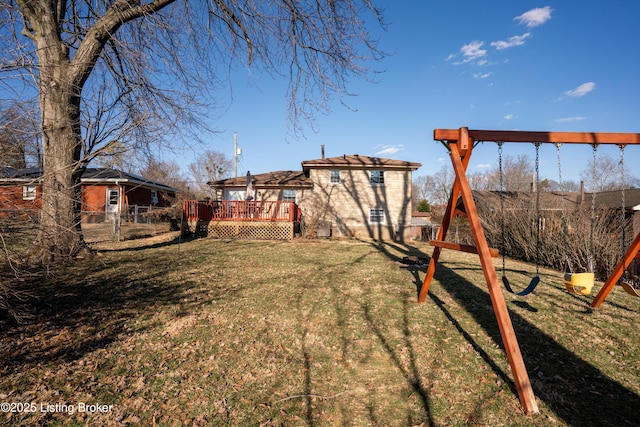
0, 168, 177, 221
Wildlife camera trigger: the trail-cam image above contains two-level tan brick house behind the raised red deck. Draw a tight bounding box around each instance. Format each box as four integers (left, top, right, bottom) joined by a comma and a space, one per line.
209, 154, 421, 241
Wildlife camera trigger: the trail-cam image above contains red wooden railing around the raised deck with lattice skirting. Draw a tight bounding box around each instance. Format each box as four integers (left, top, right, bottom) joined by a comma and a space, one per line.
184, 200, 300, 221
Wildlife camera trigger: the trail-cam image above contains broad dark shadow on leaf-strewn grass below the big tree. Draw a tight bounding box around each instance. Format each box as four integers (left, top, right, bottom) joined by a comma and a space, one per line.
0, 247, 237, 375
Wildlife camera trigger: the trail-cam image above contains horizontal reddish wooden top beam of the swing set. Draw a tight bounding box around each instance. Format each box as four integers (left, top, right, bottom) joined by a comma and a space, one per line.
433, 129, 640, 145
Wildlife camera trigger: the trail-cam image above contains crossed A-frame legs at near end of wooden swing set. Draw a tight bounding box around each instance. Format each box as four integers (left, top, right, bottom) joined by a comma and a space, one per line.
419, 128, 538, 414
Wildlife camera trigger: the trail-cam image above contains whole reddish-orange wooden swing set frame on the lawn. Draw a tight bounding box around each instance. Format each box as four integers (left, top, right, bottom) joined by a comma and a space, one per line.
418, 127, 640, 414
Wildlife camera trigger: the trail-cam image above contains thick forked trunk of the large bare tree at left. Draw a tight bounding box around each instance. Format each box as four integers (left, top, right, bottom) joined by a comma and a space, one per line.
17, 0, 174, 261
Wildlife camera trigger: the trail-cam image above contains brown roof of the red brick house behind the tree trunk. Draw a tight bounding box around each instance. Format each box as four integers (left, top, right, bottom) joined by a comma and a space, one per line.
0, 167, 178, 193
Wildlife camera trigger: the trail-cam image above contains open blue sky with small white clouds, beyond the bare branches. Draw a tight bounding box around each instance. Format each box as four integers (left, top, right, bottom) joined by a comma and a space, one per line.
178, 0, 640, 181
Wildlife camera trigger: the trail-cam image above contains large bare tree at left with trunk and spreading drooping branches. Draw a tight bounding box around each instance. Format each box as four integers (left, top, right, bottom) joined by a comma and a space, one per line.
0, 0, 381, 257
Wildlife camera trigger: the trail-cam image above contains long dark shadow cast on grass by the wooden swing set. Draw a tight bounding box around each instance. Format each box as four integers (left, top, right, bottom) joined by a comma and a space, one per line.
377, 244, 640, 426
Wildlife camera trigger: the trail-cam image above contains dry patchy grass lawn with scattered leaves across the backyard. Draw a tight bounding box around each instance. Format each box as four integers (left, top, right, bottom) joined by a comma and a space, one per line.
0, 238, 640, 426
